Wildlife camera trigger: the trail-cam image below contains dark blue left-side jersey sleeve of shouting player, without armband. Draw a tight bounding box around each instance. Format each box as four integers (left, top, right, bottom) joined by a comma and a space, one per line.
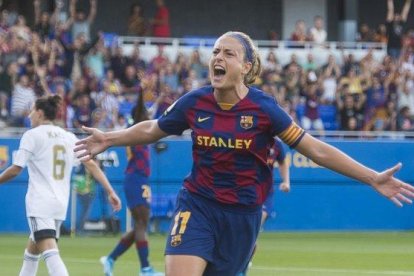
158, 96, 190, 135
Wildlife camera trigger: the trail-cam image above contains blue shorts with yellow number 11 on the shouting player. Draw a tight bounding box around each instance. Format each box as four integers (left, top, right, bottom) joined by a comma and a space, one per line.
165, 189, 262, 276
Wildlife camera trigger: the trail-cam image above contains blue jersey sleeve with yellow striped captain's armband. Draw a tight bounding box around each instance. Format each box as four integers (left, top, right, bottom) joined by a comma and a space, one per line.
264, 96, 305, 148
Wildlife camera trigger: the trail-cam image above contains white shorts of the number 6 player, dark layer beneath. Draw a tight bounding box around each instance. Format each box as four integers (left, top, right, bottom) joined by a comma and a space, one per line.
27, 217, 63, 242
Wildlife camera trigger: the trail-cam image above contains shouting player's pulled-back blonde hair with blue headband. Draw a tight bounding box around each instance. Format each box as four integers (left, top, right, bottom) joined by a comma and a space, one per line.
222, 31, 262, 85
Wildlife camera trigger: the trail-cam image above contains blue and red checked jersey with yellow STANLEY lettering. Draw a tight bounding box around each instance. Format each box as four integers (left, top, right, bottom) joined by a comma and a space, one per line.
158, 86, 304, 206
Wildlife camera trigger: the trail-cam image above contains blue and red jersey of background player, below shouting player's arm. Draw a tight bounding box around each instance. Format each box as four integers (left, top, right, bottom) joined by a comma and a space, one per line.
125, 145, 150, 177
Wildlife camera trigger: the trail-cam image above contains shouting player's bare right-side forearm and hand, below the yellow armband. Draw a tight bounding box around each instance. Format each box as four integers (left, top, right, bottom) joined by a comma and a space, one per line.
296, 134, 414, 207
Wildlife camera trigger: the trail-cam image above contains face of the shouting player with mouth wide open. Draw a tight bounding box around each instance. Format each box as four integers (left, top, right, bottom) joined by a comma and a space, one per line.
209, 36, 247, 89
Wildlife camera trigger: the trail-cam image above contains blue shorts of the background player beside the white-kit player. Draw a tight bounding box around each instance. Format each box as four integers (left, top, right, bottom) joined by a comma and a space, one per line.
124, 173, 151, 209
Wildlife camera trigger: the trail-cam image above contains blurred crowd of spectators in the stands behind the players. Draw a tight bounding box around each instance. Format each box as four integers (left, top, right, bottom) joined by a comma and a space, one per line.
0, 0, 414, 131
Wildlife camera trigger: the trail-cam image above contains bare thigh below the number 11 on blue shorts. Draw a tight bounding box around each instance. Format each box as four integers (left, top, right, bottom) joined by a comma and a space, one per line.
165, 255, 207, 276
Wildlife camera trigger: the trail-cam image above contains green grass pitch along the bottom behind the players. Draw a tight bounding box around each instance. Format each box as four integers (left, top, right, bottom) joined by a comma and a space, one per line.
0, 232, 414, 276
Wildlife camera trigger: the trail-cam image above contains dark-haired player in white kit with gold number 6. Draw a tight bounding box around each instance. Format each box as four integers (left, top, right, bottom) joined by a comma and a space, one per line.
0, 96, 121, 276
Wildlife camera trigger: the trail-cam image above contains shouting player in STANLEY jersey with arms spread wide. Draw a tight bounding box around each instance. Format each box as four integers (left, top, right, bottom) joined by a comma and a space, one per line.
75, 32, 414, 276
